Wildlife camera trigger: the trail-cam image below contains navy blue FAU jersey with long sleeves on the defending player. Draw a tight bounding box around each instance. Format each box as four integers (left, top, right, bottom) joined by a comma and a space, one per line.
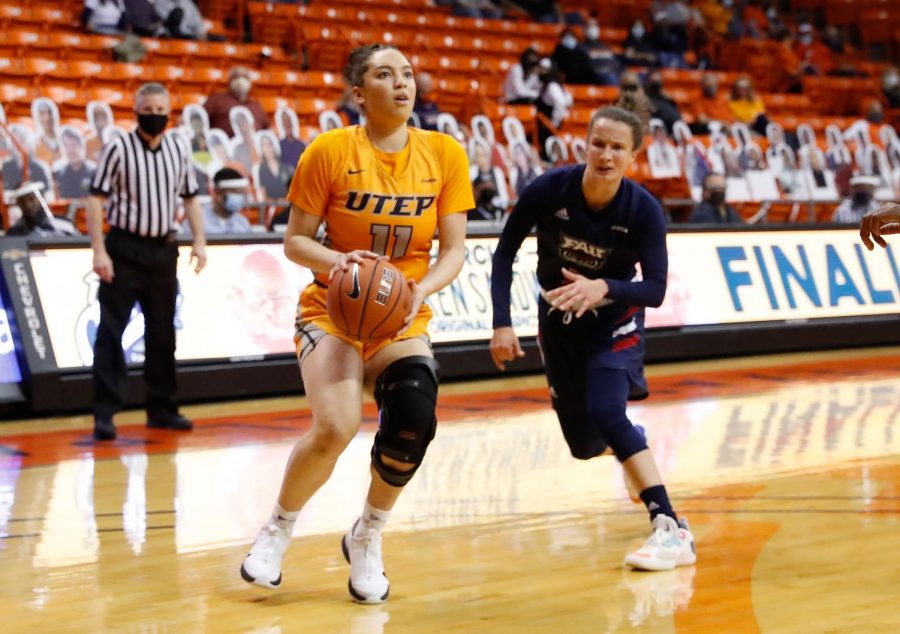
491, 165, 668, 328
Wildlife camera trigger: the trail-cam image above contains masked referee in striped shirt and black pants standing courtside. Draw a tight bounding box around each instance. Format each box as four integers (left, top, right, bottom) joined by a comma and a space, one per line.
87, 83, 206, 440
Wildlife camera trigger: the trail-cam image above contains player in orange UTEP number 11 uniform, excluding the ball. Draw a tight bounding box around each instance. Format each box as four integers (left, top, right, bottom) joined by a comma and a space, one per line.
241, 44, 475, 603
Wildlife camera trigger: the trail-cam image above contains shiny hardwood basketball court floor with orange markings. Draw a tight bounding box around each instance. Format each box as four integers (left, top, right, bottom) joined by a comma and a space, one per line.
0, 348, 900, 634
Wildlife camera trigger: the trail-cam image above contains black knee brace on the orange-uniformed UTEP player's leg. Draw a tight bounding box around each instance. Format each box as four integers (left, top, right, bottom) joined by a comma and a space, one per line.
372, 356, 439, 487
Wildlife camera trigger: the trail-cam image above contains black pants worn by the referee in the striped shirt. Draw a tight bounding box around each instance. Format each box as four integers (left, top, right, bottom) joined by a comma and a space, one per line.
94, 229, 178, 418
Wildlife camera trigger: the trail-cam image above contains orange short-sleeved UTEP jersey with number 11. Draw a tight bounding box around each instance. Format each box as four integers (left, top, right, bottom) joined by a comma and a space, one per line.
288, 126, 475, 284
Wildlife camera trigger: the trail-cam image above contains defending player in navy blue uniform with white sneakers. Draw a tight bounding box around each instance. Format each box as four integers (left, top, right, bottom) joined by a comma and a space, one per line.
491, 99, 697, 570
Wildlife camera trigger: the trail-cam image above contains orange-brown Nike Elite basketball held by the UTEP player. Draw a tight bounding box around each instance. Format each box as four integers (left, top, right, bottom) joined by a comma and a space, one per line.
327, 258, 411, 341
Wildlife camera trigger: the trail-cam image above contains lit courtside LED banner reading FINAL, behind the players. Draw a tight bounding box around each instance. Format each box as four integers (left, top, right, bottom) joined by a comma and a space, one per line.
0, 228, 900, 406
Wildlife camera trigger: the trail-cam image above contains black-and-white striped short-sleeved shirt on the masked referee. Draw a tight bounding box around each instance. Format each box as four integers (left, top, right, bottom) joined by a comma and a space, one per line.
91, 130, 197, 238
